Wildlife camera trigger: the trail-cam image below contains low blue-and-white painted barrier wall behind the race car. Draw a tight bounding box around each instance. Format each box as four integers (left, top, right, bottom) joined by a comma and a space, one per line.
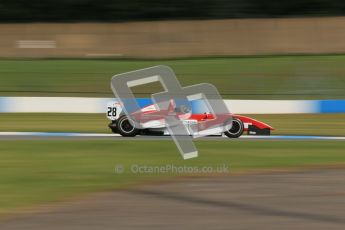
0, 97, 345, 114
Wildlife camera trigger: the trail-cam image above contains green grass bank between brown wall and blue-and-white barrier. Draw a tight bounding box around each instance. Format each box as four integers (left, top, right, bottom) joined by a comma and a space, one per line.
0, 55, 345, 99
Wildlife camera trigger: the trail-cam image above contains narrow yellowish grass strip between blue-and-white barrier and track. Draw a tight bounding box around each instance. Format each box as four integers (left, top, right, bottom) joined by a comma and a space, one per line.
0, 113, 345, 136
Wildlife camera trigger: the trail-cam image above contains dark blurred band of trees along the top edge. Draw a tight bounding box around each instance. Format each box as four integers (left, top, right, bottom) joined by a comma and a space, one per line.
0, 0, 345, 22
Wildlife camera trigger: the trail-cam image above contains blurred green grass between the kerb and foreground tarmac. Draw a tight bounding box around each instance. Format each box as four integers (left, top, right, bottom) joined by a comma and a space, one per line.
0, 140, 345, 214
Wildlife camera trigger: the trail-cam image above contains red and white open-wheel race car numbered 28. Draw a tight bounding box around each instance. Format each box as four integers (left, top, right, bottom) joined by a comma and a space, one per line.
107, 99, 274, 138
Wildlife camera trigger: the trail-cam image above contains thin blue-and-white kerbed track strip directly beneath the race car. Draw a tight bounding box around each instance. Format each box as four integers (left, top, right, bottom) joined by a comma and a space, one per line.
0, 132, 345, 141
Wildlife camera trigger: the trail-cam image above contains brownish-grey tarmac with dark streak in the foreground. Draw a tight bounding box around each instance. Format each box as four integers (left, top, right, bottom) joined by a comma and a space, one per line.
0, 169, 345, 230
